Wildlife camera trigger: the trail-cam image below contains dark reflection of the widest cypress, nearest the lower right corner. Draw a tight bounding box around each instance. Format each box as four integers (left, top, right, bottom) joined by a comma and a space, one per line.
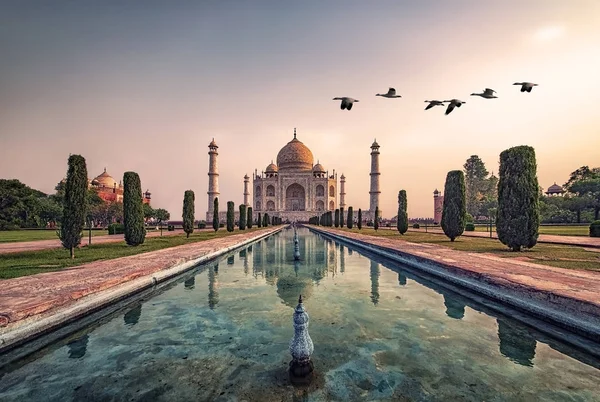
496, 318, 537, 367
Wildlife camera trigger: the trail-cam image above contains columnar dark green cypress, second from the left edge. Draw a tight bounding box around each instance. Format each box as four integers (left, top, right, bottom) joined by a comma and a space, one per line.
123, 172, 146, 246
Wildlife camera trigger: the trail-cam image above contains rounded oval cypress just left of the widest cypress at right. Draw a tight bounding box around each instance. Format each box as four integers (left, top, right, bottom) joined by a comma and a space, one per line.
441, 170, 467, 241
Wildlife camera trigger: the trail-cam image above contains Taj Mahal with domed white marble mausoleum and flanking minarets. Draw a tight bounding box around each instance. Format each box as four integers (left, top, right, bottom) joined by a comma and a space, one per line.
206, 129, 381, 222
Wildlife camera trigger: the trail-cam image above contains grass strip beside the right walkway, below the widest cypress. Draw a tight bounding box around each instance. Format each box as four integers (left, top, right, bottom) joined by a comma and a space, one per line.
336, 228, 600, 272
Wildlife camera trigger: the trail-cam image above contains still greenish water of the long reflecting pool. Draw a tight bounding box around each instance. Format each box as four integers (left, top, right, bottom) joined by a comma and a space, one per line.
0, 229, 600, 401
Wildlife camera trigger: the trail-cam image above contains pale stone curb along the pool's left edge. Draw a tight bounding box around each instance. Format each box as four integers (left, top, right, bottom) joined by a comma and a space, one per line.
0, 225, 286, 354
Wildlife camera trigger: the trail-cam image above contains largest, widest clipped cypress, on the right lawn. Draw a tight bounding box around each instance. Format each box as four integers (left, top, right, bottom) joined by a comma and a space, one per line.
496, 145, 540, 251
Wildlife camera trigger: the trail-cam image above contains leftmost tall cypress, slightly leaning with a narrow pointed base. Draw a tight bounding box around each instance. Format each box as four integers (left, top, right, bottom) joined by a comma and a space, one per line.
59, 155, 88, 258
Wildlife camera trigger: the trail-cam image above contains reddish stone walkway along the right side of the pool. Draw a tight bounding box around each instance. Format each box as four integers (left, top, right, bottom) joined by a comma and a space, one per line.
317, 226, 600, 308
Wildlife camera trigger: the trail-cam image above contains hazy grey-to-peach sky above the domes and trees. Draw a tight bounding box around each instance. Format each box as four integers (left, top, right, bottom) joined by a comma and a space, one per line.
0, 0, 600, 219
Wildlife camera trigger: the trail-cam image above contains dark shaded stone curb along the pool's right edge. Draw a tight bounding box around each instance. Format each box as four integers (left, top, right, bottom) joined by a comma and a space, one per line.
308, 226, 600, 342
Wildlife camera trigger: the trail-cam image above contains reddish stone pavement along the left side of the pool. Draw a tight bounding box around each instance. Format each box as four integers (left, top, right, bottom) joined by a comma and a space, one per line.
0, 226, 282, 334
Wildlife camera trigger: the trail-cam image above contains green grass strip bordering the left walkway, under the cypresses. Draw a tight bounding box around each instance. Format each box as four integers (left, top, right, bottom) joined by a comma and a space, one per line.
0, 228, 260, 279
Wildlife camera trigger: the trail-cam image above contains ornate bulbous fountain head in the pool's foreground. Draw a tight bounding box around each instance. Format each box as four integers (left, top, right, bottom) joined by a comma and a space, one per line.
289, 295, 315, 384
